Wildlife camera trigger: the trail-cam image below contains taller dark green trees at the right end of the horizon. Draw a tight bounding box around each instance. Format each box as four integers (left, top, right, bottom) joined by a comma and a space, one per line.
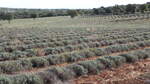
93, 2, 150, 15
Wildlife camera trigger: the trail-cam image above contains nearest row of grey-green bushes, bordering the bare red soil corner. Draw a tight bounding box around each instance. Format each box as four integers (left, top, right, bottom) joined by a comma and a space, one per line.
4, 47, 149, 84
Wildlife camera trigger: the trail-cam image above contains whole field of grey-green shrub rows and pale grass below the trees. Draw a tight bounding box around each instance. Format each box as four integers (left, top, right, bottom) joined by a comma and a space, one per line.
0, 16, 150, 84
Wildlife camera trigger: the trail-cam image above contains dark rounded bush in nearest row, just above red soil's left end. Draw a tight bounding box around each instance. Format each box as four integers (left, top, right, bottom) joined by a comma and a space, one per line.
67, 64, 87, 77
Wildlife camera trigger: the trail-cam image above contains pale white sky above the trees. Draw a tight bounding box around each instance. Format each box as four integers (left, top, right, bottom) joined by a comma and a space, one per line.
0, 0, 150, 9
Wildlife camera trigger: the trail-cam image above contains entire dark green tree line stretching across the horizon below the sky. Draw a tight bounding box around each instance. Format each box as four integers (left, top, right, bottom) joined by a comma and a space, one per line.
0, 2, 150, 23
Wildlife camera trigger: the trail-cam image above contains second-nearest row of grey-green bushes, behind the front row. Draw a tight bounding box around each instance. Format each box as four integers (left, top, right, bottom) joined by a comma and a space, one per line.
0, 41, 148, 73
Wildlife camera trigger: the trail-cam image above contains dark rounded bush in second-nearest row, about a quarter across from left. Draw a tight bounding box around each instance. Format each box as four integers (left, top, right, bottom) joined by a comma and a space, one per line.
30, 57, 49, 67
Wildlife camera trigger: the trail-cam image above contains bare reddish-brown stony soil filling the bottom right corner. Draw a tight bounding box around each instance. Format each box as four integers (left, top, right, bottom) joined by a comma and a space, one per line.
71, 59, 150, 84
